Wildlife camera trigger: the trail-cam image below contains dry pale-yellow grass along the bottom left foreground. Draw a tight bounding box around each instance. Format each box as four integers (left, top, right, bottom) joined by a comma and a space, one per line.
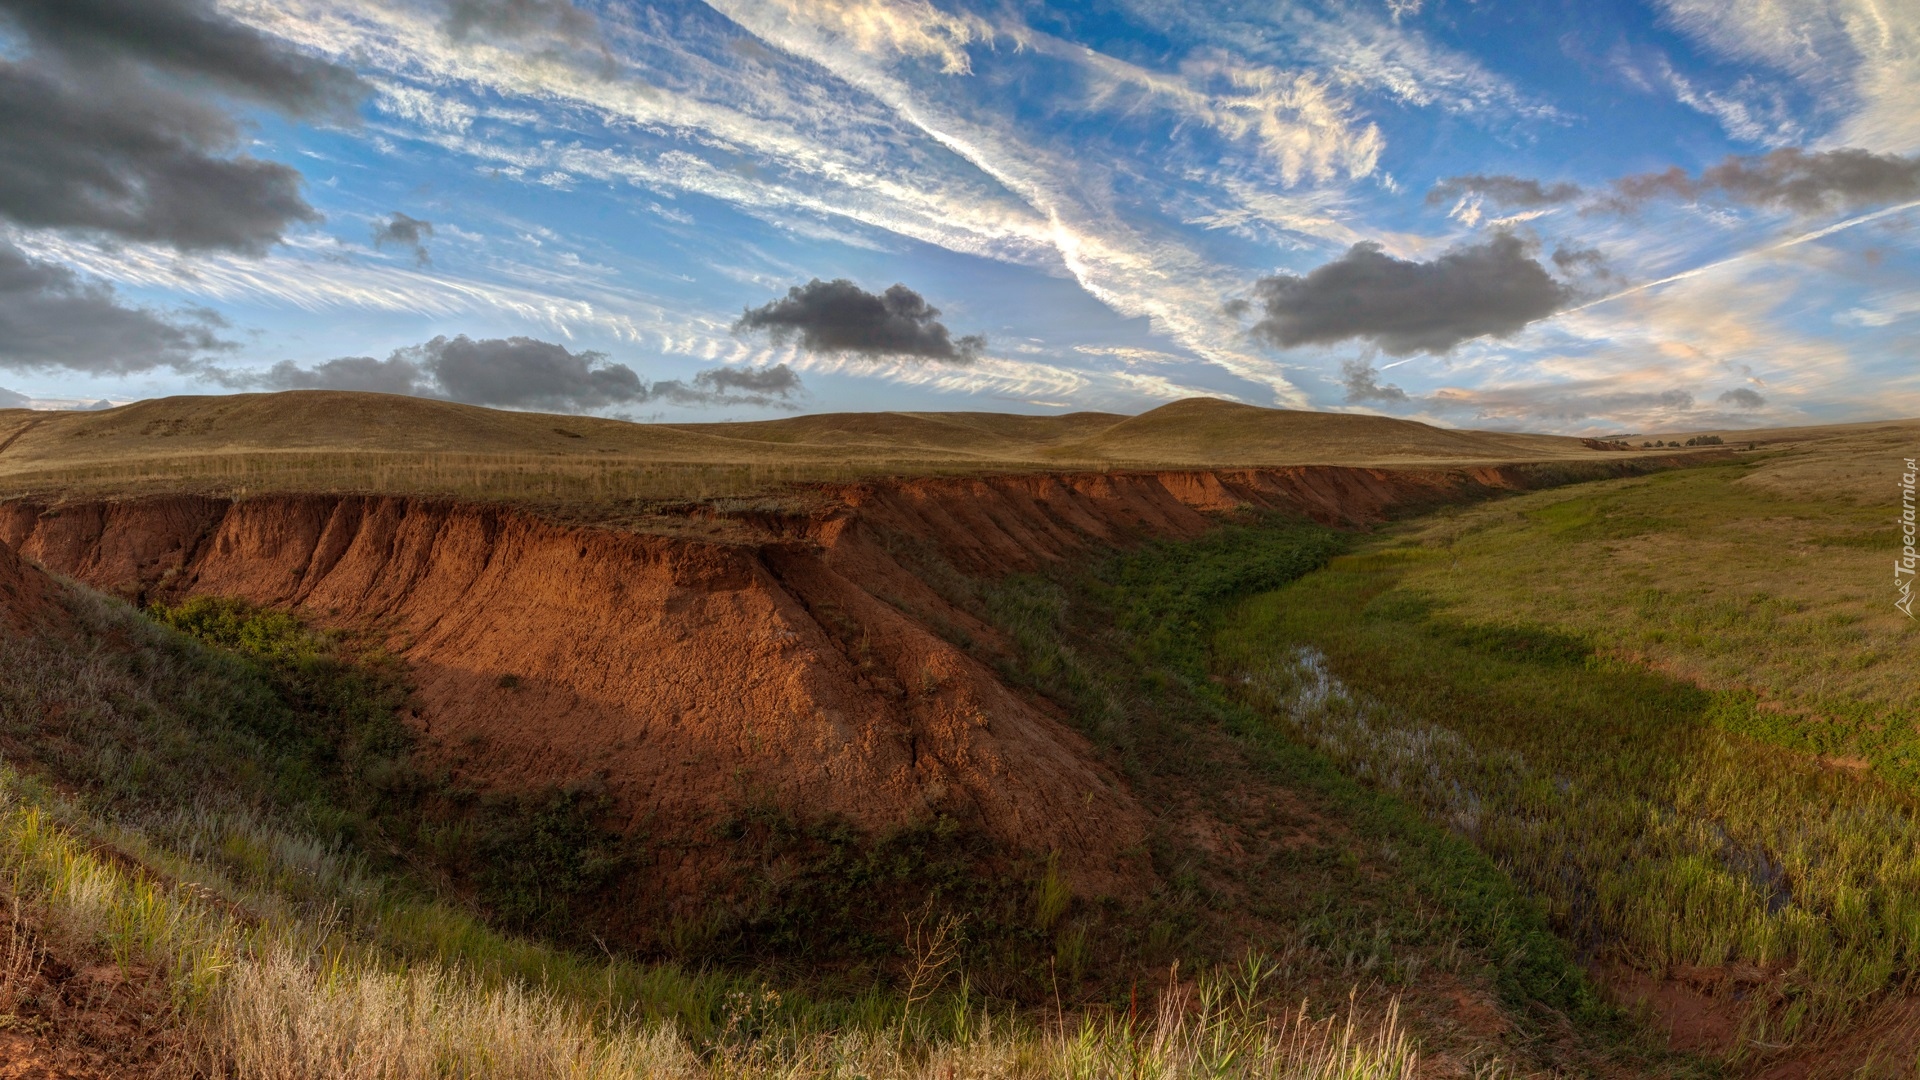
0, 767, 1419, 1080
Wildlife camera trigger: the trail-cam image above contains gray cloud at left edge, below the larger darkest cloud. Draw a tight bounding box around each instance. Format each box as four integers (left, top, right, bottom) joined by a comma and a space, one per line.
0, 242, 232, 375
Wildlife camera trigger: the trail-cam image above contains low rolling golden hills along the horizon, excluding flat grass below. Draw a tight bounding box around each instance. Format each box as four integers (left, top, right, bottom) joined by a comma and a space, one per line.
0, 390, 1596, 468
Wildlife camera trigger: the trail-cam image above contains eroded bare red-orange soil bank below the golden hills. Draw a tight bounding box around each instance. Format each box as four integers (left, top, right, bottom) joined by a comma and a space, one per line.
0, 461, 1681, 894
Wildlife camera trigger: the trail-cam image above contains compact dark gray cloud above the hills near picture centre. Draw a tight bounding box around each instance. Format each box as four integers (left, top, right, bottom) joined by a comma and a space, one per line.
733, 277, 987, 363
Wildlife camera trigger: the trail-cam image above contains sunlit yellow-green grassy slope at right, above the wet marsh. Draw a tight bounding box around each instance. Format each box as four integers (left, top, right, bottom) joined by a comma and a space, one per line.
1398, 459, 1920, 764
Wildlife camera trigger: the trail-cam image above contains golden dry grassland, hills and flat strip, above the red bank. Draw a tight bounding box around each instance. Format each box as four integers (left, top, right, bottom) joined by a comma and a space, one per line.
0, 390, 1681, 505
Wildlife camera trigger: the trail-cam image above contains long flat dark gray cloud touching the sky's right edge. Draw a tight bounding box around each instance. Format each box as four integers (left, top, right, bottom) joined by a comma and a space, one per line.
1597, 148, 1920, 213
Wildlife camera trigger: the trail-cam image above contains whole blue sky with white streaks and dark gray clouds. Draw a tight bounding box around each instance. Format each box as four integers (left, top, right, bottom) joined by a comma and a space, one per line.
0, 0, 1920, 434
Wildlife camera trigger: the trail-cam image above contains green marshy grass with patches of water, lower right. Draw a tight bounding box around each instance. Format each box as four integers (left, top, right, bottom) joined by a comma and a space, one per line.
1215, 538, 1920, 1043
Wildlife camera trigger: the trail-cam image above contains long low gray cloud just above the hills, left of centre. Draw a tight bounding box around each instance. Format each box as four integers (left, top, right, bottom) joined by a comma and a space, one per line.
224, 334, 803, 413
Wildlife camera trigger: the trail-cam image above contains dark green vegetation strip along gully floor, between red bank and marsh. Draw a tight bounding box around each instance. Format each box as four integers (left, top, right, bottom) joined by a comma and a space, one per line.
952, 519, 1693, 1072
